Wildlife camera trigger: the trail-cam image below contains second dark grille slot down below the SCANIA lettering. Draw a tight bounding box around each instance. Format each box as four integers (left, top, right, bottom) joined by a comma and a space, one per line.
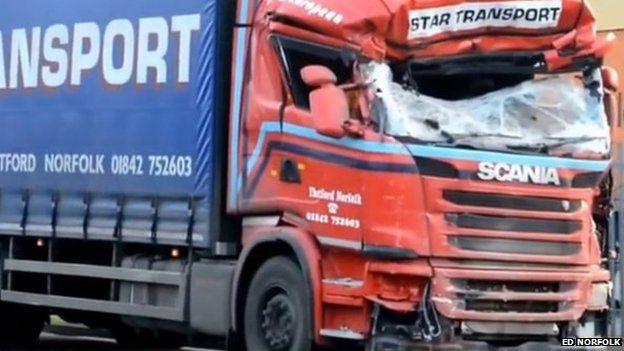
445, 213, 583, 234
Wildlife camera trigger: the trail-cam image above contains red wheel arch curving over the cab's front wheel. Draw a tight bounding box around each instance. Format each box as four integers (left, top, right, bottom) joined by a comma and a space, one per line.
230, 227, 322, 341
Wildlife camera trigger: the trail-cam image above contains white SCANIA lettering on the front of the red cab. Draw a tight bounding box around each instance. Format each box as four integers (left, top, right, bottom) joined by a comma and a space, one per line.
477, 162, 561, 185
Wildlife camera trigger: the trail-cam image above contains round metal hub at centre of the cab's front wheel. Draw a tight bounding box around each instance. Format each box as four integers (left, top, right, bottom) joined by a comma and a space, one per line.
261, 294, 295, 351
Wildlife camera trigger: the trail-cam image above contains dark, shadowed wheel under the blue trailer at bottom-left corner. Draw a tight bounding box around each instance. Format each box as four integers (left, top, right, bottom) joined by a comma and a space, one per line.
0, 303, 48, 350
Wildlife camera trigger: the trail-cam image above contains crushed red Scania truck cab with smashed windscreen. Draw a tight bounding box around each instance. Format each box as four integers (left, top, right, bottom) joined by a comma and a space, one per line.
233, 0, 617, 350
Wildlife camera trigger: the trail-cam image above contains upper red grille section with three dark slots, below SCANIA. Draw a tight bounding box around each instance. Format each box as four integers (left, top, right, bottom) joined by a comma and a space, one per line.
432, 186, 592, 263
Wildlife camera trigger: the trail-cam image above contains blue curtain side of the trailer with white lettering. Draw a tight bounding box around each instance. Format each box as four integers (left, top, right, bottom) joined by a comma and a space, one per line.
0, 0, 232, 248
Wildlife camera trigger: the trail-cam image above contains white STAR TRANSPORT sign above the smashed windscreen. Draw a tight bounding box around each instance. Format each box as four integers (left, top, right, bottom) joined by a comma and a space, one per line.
408, 0, 563, 39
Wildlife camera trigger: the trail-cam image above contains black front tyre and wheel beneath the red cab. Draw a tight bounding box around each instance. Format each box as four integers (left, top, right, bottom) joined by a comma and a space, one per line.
244, 257, 312, 351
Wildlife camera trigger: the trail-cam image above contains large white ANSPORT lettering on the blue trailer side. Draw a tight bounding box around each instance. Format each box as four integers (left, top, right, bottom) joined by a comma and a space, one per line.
0, 14, 201, 91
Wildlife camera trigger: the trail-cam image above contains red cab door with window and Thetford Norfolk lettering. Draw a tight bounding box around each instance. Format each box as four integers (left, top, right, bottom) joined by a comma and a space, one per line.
272, 35, 366, 250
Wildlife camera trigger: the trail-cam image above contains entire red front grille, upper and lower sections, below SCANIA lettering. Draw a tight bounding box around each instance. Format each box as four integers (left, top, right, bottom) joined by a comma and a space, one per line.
424, 180, 594, 322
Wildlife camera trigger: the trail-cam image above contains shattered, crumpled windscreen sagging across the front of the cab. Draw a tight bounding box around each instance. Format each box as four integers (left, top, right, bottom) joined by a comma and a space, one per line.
360, 62, 610, 156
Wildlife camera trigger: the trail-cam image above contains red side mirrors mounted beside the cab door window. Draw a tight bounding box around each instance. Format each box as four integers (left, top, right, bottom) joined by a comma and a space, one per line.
301, 65, 349, 138
